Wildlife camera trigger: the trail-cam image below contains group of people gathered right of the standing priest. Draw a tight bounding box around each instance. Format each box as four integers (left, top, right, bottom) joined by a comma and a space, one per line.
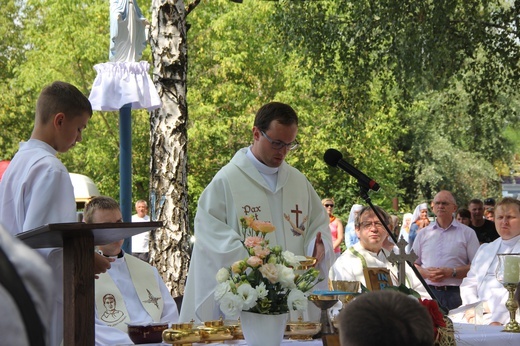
322, 190, 520, 325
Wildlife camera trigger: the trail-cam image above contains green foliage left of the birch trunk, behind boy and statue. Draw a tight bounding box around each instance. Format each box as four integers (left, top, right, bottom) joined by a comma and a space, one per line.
0, 0, 150, 204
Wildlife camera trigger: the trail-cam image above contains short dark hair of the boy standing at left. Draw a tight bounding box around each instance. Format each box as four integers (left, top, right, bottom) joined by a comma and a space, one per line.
36, 81, 92, 125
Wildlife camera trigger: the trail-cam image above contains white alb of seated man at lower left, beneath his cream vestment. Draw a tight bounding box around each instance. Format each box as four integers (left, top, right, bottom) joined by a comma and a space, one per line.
95, 253, 179, 346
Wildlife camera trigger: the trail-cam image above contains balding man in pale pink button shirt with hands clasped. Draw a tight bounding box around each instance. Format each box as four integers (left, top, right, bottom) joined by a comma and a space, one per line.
413, 190, 480, 310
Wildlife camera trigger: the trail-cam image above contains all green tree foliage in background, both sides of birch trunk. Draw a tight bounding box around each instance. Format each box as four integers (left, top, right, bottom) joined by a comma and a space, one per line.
0, 0, 520, 230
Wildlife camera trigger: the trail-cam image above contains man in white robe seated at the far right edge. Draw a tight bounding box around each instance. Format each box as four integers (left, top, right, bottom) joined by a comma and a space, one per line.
460, 197, 520, 325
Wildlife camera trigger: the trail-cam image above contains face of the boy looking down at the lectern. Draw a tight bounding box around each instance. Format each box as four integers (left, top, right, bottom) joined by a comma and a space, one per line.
54, 112, 90, 153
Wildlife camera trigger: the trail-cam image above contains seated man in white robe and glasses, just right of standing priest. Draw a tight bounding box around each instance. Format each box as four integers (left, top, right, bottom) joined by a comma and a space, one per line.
329, 206, 431, 299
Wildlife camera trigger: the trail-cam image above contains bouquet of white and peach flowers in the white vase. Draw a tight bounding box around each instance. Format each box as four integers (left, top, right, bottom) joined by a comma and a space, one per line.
215, 216, 322, 316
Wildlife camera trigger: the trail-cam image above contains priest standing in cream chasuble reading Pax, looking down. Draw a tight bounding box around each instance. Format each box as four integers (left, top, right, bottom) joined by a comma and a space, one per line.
180, 102, 334, 322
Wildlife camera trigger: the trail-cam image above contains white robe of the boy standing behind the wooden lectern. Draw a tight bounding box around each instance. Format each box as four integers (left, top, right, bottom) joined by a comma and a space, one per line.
0, 139, 77, 345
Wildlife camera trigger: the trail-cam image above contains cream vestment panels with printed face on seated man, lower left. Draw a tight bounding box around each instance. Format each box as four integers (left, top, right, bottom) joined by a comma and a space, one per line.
95, 254, 164, 333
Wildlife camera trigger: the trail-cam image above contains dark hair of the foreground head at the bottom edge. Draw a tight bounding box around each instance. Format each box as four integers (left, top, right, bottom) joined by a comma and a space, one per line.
338, 290, 434, 346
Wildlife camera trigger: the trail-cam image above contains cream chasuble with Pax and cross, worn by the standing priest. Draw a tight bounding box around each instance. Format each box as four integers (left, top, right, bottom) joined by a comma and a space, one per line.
180, 148, 333, 322
